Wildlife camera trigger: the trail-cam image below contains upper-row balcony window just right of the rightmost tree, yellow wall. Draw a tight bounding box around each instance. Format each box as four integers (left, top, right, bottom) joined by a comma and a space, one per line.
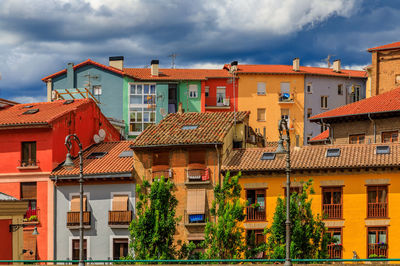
322, 187, 342, 219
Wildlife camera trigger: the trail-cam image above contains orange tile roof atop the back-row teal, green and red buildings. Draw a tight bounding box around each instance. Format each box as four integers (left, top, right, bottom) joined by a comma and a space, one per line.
124, 68, 232, 80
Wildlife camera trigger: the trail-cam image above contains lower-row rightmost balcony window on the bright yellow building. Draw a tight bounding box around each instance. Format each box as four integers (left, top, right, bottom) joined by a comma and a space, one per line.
367, 227, 388, 258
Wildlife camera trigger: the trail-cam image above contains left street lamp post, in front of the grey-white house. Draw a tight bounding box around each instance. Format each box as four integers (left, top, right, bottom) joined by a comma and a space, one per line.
63, 134, 85, 266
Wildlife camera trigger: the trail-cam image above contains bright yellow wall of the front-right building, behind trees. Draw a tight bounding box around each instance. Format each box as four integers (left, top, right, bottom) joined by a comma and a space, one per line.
240, 171, 400, 259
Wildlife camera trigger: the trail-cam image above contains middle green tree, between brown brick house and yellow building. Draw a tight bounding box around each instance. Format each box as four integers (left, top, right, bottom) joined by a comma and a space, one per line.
202, 173, 246, 259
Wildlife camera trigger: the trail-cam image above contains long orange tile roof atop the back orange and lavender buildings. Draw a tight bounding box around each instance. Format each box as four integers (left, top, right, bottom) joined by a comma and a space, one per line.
237, 65, 368, 78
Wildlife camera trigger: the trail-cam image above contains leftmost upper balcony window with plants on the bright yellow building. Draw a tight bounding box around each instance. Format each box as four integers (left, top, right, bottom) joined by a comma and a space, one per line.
246, 189, 266, 221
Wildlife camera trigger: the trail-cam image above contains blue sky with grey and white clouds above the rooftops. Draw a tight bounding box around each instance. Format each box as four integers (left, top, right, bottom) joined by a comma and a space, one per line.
0, 0, 400, 102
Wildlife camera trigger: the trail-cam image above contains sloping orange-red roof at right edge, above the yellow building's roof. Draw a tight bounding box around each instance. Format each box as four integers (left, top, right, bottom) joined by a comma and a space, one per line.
310, 87, 400, 122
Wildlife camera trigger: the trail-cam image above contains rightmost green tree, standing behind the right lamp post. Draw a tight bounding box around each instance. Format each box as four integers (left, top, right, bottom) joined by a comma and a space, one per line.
265, 179, 332, 259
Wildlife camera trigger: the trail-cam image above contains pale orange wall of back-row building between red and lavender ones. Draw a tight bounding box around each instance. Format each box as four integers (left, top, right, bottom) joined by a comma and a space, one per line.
238, 74, 304, 146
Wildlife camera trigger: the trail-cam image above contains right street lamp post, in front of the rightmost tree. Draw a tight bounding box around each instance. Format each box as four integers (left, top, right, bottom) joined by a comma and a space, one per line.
275, 119, 292, 266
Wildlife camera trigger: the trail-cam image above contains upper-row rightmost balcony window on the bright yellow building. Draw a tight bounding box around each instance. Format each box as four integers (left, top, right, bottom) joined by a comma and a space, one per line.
367, 186, 388, 217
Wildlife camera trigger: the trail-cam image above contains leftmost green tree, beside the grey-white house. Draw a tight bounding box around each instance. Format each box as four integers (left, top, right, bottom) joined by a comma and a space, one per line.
126, 177, 180, 260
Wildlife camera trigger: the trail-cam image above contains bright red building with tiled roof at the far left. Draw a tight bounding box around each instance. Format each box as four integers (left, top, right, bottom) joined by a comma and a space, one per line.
0, 99, 121, 260
